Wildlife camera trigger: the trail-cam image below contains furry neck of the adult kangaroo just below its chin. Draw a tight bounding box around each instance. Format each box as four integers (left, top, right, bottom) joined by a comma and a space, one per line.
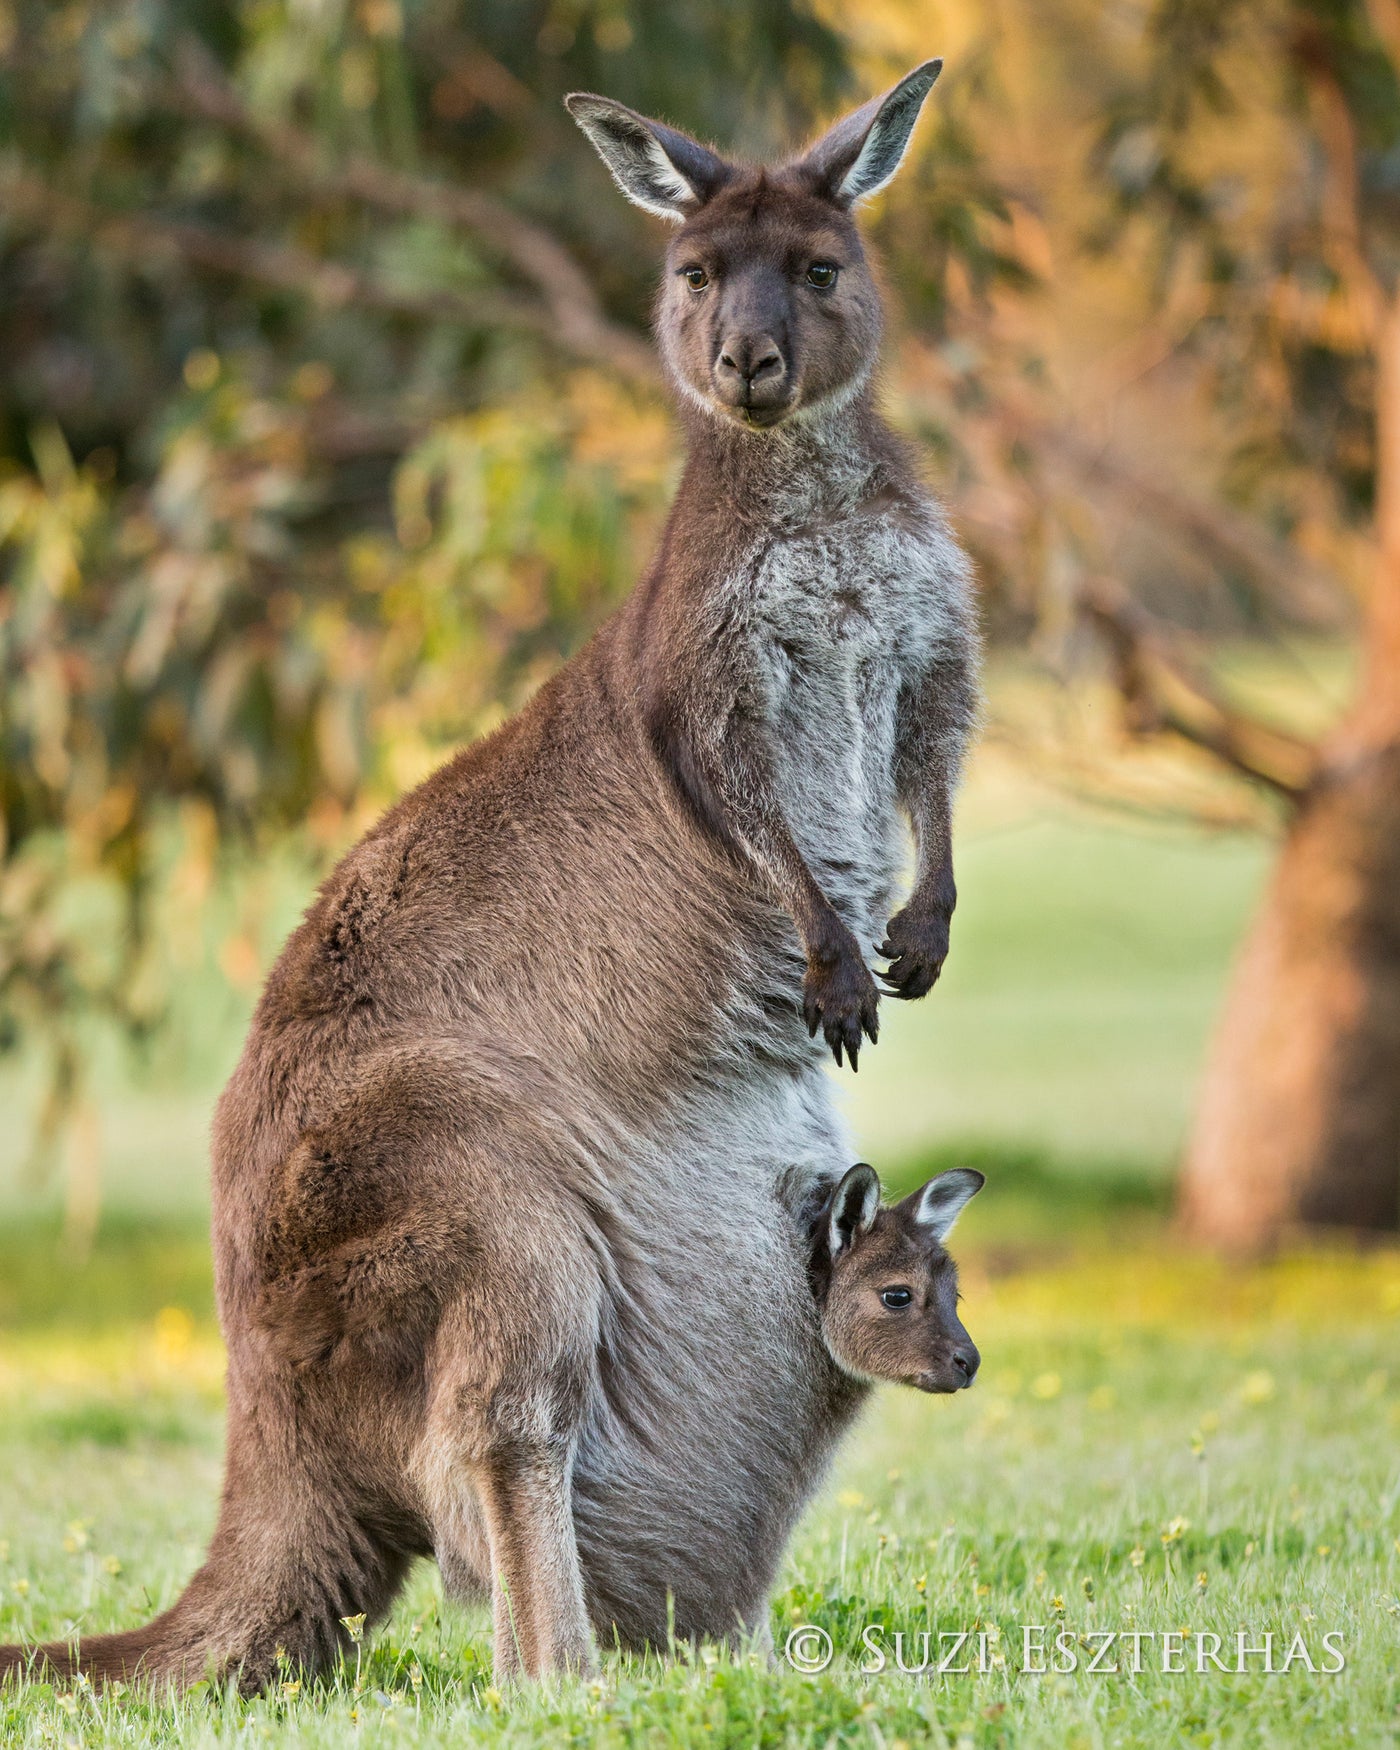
672, 396, 889, 530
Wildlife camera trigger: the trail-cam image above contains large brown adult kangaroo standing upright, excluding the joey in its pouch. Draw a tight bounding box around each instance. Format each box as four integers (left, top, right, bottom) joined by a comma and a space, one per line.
0, 61, 977, 1689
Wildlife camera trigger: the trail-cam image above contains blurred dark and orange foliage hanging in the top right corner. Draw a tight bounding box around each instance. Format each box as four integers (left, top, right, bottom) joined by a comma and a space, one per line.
1097, 0, 1400, 530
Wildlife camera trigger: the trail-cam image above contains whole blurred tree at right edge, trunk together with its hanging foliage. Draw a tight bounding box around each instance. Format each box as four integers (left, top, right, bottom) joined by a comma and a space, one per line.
1089, 0, 1400, 1248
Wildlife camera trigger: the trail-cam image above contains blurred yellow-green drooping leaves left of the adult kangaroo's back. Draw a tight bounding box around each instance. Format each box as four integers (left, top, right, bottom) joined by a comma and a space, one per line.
0, 372, 679, 1106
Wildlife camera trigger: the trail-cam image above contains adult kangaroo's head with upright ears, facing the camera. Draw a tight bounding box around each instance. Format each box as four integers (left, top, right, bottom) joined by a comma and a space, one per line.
564, 61, 943, 431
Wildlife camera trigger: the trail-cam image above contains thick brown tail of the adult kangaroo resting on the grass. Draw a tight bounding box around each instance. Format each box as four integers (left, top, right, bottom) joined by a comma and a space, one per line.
0, 1498, 410, 1694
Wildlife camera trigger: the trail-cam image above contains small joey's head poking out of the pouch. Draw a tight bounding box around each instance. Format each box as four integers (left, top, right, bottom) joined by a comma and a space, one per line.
812, 1166, 985, 1391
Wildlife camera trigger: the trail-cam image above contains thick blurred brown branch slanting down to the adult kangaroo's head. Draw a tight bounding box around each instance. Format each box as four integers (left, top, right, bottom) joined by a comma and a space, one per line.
168, 39, 658, 389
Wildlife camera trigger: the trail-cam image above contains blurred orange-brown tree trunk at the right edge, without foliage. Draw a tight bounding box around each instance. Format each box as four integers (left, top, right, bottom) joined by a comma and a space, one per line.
1181, 298, 1400, 1251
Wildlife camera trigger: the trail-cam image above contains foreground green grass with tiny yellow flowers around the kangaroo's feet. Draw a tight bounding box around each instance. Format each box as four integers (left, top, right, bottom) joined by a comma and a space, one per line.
0, 1211, 1400, 1750
